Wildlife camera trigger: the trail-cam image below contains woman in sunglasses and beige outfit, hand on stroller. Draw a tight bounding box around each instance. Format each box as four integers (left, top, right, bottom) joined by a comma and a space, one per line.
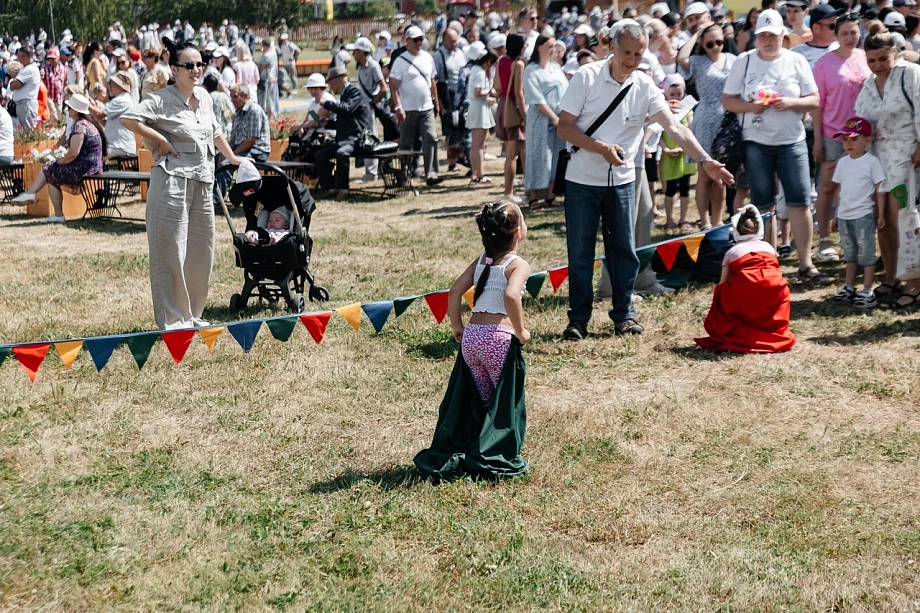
121, 38, 240, 330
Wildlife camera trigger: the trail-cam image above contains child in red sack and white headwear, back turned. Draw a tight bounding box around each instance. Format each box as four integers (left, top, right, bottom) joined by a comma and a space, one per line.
694, 204, 795, 353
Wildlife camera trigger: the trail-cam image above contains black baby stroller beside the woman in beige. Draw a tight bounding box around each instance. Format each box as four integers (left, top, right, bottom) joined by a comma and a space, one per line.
218, 162, 329, 313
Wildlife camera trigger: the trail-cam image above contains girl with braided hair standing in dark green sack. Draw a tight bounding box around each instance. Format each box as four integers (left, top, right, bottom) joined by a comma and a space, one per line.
415, 202, 530, 480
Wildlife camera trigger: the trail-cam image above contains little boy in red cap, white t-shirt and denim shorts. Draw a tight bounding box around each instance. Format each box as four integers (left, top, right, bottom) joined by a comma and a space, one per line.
831, 117, 887, 309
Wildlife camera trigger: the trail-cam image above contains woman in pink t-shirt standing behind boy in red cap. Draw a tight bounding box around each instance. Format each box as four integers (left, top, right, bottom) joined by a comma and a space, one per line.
812, 13, 871, 261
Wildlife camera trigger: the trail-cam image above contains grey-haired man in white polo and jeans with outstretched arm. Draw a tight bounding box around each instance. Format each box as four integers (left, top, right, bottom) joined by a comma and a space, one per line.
557, 19, 733, 340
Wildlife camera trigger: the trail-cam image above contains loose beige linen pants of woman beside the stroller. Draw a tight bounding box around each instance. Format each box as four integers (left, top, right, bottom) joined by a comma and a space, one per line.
147, 166, 214, 330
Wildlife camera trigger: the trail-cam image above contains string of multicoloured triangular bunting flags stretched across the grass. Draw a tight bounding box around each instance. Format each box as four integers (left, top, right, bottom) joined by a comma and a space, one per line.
0, 220, 736, 382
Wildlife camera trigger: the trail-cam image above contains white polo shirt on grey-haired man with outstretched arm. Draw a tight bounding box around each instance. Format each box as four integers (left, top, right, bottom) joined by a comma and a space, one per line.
562, 60, 669, 187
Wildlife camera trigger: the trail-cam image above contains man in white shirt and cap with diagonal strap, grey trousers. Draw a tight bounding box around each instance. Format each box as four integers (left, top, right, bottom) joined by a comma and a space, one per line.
390, 26, 442, 185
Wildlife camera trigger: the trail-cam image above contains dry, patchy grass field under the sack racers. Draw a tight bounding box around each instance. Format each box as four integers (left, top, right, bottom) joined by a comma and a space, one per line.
0, 147, 920, 613
